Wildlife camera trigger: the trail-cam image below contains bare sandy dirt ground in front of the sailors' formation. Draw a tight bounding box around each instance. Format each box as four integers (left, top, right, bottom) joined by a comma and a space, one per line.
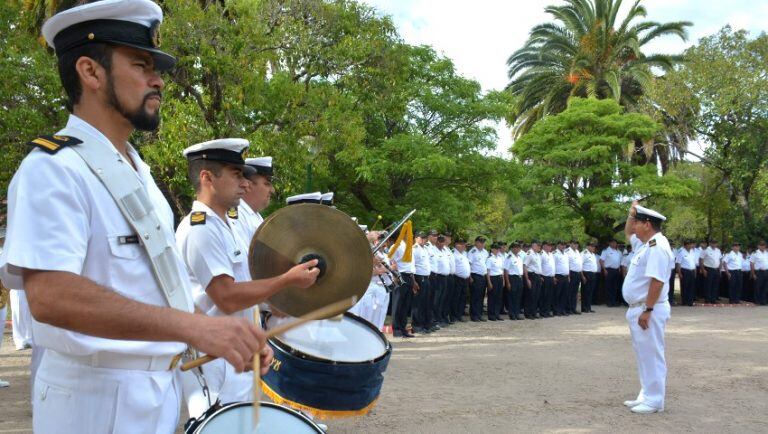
0, 306, 768, 433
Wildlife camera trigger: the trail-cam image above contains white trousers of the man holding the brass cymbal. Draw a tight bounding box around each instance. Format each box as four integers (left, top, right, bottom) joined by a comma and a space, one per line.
179, 359, 253, 418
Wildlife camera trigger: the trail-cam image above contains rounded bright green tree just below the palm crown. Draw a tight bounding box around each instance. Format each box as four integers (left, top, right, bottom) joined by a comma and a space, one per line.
512, 98, 693, 242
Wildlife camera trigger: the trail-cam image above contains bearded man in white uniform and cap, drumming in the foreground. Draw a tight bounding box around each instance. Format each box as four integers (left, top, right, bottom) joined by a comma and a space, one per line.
0, 0, 271, 434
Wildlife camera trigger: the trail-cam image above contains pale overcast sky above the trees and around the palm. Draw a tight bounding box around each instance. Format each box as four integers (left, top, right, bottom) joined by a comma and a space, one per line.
363, 0, 768, 155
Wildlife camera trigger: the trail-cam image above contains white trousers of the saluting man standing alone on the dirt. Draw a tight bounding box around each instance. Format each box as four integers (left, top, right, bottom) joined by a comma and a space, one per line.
627, 302, 670, 409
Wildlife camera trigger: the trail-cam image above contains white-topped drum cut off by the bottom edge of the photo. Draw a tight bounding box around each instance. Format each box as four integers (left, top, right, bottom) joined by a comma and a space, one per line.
184, 402, 324, 434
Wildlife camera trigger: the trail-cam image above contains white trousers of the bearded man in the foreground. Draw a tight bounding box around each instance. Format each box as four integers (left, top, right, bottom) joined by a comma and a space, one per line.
32, 350, 181, 434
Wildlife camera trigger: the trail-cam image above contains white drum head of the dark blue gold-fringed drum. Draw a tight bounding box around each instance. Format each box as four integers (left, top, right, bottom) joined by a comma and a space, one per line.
267, 314, 389, 363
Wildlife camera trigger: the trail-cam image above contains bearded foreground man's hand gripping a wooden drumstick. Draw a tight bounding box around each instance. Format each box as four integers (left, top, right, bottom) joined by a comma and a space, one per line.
188, 315, 267, 372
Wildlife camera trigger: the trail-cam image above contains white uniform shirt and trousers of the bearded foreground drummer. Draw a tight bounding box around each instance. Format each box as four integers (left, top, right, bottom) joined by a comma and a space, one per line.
0, 115, 192, 433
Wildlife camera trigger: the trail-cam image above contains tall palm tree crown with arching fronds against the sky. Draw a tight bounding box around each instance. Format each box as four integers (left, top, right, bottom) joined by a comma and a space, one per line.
507, 0, 691, 137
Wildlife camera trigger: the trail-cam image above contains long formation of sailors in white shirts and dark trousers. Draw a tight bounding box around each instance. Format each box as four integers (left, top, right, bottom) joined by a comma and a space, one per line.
391, 234, 768, 337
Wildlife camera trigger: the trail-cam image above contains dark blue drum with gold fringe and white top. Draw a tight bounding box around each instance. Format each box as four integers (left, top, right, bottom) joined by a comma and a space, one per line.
262, 313, 392, 419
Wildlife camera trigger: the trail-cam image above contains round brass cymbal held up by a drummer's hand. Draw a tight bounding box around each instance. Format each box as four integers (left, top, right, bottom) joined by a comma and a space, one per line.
248, 203, 373, 316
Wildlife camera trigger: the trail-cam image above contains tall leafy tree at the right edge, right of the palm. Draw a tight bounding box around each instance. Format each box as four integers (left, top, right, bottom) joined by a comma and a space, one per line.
659, 27, 768, 242
